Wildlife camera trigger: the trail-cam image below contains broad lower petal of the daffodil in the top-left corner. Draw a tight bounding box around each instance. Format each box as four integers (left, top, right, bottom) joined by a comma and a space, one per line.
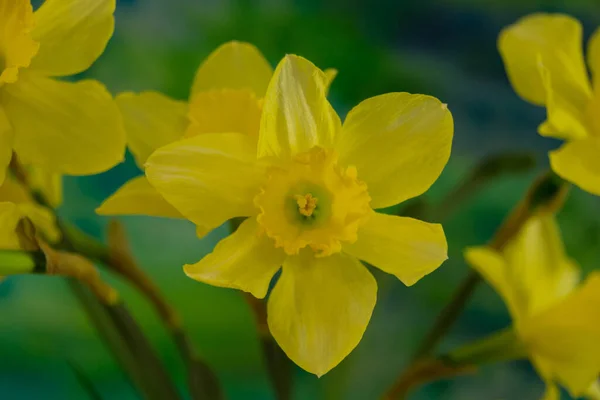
2, 75, 125, 175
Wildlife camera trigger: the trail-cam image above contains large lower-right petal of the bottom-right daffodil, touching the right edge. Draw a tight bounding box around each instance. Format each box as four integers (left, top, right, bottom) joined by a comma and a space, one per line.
520, 272, 600, 397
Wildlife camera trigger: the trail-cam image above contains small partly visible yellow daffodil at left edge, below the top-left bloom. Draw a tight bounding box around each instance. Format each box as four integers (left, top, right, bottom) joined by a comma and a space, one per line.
0, 176, 60, 250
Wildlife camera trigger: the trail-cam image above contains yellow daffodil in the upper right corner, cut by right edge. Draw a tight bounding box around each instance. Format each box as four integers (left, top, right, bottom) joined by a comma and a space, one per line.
498, 14, 600, 195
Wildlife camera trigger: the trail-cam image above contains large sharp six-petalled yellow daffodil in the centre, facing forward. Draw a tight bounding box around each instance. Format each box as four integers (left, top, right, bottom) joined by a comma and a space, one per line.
146, 56, 453, 375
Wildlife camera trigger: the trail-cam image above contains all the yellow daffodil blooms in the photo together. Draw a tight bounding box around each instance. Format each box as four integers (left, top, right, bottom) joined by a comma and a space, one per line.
0, 0, 600, 398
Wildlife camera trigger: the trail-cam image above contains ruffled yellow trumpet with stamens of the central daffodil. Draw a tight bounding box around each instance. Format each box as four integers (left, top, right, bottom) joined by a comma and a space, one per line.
254, 147, 371, 256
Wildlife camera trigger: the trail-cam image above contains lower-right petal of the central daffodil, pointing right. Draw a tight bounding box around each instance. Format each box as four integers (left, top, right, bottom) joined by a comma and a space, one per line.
343, 213, 448, 286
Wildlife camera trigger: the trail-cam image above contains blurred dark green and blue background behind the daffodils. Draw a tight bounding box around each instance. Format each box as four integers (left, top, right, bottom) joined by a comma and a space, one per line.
0, 0, 600, 400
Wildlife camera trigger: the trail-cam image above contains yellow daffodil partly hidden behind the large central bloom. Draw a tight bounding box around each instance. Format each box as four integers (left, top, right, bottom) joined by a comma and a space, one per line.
96, 41, 336, 236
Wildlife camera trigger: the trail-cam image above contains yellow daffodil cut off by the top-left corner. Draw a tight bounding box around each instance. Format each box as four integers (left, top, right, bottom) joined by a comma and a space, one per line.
0, 0, 125, 184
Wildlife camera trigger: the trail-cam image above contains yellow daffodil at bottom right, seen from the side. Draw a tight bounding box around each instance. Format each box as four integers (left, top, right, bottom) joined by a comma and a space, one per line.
465, 215, 600, 400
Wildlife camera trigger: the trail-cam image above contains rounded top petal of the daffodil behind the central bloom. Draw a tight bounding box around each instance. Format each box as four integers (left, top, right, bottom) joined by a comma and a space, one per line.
192, 41, 273, 97
